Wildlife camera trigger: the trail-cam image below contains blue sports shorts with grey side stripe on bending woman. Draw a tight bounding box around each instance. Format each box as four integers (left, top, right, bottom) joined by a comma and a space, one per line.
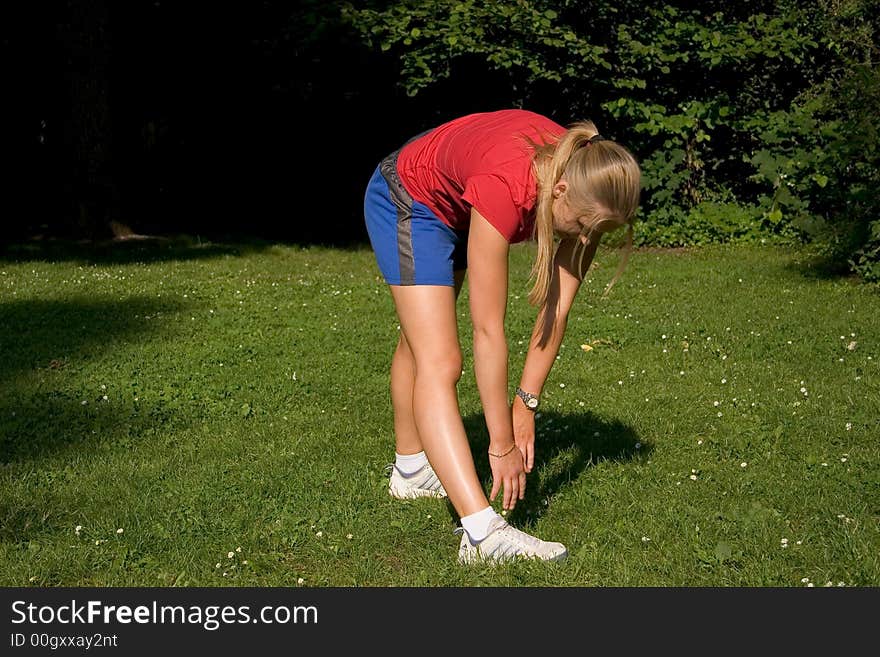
364, 151, 467, 286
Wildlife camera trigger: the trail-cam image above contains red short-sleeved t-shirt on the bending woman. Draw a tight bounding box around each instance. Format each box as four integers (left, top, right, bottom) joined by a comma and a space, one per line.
397, 110, 565, 243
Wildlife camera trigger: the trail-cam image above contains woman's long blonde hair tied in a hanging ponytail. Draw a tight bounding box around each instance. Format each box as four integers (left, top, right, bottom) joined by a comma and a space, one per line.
529, 121, 641, 306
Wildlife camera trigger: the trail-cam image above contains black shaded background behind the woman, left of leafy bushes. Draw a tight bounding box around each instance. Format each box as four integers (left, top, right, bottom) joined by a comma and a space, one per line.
6, 0, 552, 244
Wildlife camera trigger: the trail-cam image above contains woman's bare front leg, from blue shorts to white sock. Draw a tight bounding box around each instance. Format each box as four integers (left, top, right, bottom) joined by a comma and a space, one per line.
391, 276, 489, 516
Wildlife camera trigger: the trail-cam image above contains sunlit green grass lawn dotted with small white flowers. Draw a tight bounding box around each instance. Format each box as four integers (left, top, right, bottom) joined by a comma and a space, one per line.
0, 238, 880, 587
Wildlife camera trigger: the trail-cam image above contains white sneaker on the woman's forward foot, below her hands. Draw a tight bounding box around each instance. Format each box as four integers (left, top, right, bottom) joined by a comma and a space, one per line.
455, 516, 568, 564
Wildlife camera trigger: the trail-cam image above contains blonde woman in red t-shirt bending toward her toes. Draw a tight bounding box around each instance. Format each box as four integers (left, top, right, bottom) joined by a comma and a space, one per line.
364, 110, 640, 563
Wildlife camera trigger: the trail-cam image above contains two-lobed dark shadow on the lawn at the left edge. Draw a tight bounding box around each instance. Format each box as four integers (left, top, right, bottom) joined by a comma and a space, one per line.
0, 297, 192, 463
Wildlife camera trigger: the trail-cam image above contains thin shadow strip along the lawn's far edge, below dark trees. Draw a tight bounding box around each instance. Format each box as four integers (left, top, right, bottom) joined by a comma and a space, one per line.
0, 235, 369, 265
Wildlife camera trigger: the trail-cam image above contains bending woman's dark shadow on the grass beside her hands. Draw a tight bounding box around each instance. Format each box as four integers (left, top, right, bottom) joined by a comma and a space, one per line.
447, 411, 651, 528
